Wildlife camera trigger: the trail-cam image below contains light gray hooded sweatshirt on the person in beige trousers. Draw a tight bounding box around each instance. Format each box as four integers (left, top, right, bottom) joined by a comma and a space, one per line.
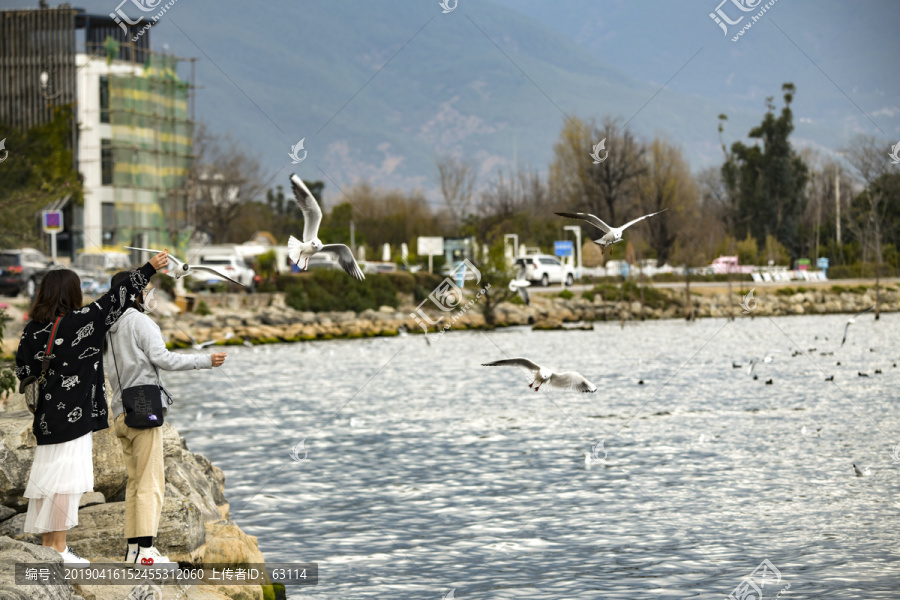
103, 308, 212, 418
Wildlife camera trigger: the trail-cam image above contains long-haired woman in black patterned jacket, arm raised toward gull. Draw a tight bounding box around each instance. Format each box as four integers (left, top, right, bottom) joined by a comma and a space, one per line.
16, 252, 168, 563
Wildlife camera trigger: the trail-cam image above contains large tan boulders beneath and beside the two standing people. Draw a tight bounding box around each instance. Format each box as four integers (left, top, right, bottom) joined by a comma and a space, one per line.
0, 395, 283, 600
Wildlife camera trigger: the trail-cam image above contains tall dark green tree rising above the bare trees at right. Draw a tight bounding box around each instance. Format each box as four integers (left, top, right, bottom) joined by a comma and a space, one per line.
720, 83, 808, 256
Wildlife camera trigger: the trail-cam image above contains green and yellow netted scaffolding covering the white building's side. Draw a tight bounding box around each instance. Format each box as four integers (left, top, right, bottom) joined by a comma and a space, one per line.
102, 38, 194, 250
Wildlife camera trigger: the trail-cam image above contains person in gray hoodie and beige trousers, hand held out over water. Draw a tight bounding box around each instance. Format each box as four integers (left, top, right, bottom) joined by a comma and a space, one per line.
103, 272, 225, 568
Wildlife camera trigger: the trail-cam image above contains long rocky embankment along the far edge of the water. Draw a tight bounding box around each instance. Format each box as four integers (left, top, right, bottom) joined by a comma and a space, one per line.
154, 286, 900, 348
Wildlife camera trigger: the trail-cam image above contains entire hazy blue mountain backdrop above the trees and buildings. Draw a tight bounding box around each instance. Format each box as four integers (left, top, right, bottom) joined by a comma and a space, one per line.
10, 0, 900, 200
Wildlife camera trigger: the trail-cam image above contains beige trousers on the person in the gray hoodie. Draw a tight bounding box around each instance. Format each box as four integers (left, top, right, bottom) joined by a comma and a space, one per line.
115, 414, 166, 538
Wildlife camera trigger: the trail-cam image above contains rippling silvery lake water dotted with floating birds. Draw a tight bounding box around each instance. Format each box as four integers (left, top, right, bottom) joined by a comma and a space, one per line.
164, 315, 900, 600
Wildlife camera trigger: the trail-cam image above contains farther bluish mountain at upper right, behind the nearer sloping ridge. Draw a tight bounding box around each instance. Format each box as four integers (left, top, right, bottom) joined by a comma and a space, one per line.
496, 0, 900, 144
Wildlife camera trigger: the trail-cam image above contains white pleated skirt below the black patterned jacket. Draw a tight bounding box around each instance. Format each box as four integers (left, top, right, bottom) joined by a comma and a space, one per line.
25, 433, 94, 533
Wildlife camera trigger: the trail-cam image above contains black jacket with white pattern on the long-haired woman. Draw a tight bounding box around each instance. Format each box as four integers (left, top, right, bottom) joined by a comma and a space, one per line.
16, 263, 156, 446
